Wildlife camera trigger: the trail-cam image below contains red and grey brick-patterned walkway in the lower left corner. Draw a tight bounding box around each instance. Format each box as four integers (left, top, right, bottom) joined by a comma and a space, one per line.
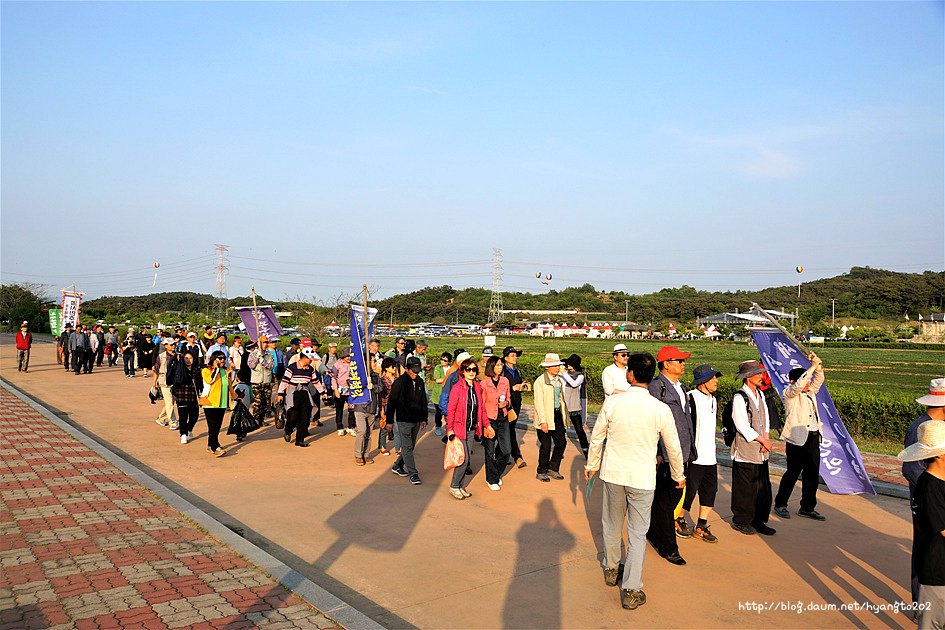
0, 388, 339, 630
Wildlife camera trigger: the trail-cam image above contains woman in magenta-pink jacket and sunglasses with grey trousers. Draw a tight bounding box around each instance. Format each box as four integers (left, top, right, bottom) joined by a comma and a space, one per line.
446, 359, 495, 500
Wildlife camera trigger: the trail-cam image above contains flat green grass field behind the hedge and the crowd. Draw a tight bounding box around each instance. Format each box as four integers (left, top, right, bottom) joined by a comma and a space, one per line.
416, 336, 945, 396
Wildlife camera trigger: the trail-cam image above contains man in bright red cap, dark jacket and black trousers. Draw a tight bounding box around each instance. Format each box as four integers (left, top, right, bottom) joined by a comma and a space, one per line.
646, 346, 696, 565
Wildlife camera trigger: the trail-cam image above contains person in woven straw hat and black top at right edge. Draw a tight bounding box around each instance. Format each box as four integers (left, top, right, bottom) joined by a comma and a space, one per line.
898, 420, 945, 630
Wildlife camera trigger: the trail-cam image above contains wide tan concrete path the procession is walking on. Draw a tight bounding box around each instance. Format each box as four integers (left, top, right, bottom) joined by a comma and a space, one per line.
0, 341, 912, 628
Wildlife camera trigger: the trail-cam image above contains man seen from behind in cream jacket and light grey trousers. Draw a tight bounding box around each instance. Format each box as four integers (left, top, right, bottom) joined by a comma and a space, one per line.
584, 353, 686, 610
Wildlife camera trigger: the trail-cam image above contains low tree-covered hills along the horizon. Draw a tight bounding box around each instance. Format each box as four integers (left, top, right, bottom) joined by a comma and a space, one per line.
82, 267, 945, 323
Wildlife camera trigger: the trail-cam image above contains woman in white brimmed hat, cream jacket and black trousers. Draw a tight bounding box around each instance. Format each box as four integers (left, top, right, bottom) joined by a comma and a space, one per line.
534, 352, 569, 482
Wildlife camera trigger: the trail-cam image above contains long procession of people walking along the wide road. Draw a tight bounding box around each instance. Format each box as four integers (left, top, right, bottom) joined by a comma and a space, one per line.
24, 326, 945, 628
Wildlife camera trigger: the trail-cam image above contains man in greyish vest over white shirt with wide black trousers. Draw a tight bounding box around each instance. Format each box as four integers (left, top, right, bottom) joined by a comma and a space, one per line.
732, 361, 775, 536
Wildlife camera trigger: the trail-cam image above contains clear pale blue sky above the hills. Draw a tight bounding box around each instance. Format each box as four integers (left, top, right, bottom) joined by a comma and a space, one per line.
0, 2, 945, 299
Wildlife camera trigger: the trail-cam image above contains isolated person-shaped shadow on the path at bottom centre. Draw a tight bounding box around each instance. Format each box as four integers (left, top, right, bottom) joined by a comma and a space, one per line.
502, 499, 574, 628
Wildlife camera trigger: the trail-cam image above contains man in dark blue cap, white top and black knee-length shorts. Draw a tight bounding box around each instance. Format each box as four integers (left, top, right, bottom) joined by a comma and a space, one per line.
681, 364, 722, 543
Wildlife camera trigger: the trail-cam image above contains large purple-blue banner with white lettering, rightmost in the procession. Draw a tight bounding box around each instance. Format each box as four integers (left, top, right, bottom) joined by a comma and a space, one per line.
751, 328, 876, 494
